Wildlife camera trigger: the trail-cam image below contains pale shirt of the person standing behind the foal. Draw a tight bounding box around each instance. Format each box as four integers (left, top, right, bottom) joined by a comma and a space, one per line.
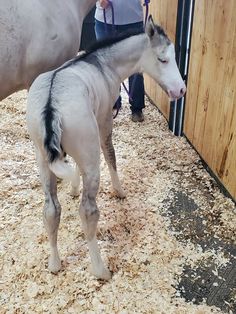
95, 0, 143, 25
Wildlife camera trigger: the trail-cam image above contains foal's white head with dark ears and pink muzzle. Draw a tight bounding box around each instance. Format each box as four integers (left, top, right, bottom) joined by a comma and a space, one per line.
142, 16, 186, 100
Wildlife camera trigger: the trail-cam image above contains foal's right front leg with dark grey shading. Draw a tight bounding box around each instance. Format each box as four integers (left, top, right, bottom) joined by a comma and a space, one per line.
100, 121, 125, 198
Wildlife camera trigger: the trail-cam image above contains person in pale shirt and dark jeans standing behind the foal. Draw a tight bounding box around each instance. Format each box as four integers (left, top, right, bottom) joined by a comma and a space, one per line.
95, 0, 145, 122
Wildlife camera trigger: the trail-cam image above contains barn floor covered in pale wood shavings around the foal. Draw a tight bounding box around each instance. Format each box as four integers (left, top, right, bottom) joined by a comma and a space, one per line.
0, 92, 236, 314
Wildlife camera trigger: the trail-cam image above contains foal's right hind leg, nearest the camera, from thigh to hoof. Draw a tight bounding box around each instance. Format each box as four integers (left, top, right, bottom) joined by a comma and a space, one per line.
62, 111, 111, 279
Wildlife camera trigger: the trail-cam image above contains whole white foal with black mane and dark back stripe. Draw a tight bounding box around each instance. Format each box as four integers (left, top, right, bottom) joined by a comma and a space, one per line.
27, 17, 186, 279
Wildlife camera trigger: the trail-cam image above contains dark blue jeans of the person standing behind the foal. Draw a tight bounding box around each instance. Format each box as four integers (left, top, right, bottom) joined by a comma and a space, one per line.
95, 20, 145, 113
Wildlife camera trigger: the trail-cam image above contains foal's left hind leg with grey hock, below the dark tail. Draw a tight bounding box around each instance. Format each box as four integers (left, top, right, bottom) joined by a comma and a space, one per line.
37, 151, 61, 273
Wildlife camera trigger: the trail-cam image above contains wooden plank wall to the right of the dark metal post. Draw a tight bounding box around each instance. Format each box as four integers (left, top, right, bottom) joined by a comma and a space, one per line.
184, 0, 236, 199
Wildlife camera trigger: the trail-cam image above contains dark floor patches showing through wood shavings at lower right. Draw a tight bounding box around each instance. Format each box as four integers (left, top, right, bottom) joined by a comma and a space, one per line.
167, 191, 236, 313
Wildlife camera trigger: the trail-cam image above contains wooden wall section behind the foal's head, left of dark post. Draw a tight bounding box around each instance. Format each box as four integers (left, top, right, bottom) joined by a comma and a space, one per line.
145, 0, 178, 119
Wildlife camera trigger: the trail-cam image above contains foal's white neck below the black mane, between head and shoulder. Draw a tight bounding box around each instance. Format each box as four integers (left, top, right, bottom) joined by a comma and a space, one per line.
103, 33, 148, 82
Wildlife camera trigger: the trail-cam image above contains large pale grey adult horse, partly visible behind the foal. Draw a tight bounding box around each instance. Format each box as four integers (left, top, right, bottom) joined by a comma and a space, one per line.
0, 0, 96, 100
